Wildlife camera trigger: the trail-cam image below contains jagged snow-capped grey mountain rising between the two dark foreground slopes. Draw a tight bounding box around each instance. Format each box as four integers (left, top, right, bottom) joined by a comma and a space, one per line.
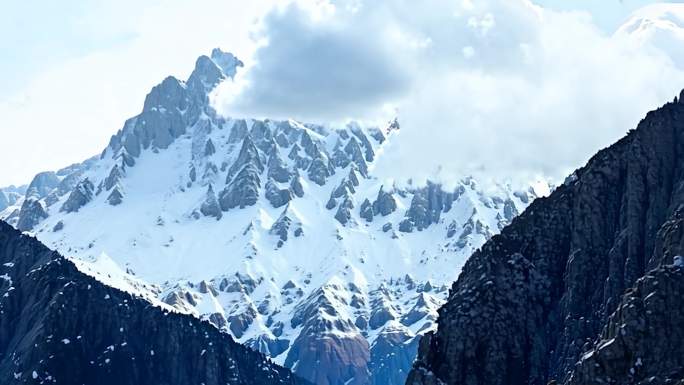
2, 49, 549, 385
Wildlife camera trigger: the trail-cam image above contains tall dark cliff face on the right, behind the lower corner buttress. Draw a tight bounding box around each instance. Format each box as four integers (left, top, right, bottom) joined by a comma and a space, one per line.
408, 93, 684, 385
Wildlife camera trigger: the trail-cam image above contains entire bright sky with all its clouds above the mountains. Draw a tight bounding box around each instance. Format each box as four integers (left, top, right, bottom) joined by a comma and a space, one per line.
0, 0, 684, 186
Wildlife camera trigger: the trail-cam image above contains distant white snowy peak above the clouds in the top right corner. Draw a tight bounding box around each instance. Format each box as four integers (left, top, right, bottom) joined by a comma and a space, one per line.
616, 3, 684, 68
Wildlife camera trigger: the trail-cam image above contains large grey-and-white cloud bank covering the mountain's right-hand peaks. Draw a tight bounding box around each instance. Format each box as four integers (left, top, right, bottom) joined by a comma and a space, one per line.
215, 0, 684, 180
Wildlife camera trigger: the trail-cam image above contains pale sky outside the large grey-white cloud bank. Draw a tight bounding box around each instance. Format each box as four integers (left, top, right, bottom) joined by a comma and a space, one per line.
0, 0, 682, 186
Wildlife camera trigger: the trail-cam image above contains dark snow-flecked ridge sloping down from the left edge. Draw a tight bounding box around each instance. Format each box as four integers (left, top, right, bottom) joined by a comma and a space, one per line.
0, 221, 302, 385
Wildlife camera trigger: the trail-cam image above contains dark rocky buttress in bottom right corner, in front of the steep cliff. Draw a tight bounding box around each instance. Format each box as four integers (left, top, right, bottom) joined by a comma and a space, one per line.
568, 263, 684, 385
